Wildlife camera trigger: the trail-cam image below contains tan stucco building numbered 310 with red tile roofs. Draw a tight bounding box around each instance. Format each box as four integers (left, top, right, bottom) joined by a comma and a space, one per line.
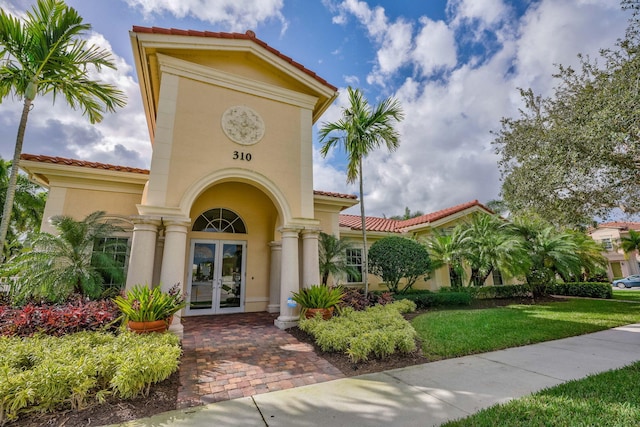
20, 27, 500, 333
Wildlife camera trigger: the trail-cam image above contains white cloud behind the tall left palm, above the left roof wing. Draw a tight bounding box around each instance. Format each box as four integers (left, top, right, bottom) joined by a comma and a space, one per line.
0, 28, 151, 168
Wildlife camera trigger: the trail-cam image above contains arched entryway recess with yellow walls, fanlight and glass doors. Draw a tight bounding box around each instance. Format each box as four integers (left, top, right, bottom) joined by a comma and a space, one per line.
185, 181, 279, 316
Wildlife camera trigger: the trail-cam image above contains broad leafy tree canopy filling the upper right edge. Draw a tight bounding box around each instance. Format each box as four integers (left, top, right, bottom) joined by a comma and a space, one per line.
493, 0, 640, 226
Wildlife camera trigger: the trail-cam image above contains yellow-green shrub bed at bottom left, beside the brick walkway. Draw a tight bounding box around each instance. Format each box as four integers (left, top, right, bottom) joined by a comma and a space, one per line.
0, 332, 181, 425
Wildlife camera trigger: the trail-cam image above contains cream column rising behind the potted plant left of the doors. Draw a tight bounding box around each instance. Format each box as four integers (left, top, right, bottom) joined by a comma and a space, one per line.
160, 218, 191, 337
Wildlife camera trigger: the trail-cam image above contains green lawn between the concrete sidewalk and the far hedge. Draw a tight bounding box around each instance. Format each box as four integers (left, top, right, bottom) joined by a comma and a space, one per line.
412, 299, 640, 360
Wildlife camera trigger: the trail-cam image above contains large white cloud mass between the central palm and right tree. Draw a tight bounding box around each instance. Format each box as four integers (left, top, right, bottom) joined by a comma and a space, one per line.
316, 0, 627, 215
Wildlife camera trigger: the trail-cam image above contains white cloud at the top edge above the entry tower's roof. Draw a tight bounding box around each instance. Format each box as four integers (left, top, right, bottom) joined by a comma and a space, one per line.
126, 0, 287, 32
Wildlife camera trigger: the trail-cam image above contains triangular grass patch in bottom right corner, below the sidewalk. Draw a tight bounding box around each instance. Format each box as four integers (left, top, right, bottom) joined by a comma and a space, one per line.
443, 362, 640, 427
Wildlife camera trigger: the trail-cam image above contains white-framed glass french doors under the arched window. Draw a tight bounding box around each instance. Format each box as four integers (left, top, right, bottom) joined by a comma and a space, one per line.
186, 239, 247, 316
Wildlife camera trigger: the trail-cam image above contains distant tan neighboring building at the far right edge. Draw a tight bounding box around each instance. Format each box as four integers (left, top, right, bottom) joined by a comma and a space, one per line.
589, 222, 640, 280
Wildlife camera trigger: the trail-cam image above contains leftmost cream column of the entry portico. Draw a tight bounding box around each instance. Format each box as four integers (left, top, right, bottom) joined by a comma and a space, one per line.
126, 217, 161, 290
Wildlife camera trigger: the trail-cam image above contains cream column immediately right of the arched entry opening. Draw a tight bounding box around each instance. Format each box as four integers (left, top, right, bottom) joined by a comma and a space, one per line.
274, 227, 300, 329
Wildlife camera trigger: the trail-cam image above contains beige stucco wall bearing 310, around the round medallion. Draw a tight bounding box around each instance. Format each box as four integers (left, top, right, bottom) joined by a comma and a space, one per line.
150, 78, 313, 224
